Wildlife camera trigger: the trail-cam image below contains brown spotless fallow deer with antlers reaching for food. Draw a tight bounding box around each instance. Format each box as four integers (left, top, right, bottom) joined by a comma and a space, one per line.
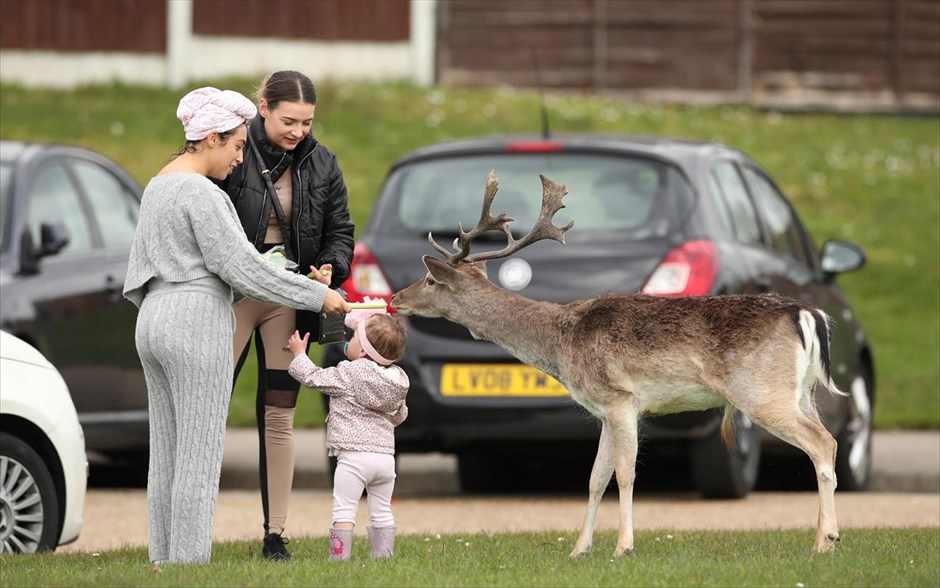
391, 172, 844, 557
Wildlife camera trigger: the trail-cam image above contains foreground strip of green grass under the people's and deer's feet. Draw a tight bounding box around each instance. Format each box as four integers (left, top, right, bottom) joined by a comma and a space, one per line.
0, 528, 940, 588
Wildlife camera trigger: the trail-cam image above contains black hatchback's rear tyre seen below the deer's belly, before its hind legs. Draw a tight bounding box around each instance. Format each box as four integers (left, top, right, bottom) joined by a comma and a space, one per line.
690, 412, 761, 498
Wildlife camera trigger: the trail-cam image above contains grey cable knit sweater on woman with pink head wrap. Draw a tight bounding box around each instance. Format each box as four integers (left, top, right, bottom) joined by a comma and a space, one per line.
124, 173, 327, 312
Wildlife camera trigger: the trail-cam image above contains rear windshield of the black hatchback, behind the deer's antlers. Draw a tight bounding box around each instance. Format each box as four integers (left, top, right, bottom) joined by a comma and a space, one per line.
373, 153, 691, 239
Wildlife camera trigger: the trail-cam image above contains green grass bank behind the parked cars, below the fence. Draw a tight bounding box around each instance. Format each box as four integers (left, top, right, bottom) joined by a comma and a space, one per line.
0, 80, 940, 429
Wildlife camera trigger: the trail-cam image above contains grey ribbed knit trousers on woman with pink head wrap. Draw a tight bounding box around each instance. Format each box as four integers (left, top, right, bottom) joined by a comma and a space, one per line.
136, 278, 235, 563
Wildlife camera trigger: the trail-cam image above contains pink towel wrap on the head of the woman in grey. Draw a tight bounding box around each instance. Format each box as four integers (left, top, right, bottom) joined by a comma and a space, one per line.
176, 86, 258, 141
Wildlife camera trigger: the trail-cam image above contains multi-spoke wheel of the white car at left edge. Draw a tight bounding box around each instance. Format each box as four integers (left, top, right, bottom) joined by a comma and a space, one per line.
0, 433, 59, 553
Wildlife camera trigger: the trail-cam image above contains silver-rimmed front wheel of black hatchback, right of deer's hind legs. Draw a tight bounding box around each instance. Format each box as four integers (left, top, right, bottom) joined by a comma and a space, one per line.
836, 376, 872, 491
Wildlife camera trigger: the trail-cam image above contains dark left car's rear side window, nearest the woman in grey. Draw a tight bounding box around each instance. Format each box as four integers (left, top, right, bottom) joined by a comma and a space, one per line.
72, 160, 139, 247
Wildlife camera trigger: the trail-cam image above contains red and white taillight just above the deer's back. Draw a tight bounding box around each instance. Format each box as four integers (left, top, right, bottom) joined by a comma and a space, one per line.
640, 241, 718, 297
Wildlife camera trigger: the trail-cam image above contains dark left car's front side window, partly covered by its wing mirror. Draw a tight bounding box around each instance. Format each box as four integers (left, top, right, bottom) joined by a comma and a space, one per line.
28, 163, 93, 253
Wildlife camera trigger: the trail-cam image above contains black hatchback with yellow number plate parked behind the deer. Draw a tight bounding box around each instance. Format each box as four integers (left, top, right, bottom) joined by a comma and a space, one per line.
325, 134, 874, 497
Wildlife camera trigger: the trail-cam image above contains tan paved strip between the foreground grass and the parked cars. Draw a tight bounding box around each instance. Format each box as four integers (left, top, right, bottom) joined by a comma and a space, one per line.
60, 489, 940, 557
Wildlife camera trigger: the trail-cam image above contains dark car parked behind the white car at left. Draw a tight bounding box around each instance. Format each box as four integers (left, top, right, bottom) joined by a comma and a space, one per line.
0, 141, 149, 470
